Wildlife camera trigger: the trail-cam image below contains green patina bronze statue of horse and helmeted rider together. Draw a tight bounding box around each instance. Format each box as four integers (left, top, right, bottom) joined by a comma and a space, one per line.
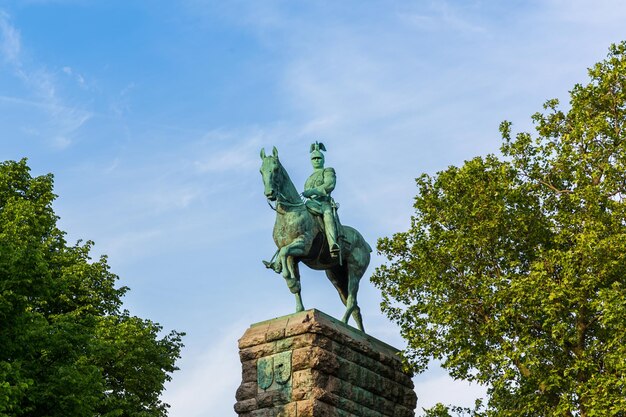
261, 142, 372, 331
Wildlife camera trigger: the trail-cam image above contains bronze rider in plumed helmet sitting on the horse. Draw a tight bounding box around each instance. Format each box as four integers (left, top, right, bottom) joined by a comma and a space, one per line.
302, 142, 341, 257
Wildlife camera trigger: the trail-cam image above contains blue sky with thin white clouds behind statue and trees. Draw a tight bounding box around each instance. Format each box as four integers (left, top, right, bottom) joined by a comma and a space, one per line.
0, 0, 626, 417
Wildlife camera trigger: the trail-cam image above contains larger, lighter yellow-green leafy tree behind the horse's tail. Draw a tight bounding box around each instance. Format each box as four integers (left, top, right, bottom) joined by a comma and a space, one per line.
372, 42, 626, 417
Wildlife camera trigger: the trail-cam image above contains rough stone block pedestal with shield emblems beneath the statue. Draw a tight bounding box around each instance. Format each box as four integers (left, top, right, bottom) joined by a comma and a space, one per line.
235, 310, 417, 417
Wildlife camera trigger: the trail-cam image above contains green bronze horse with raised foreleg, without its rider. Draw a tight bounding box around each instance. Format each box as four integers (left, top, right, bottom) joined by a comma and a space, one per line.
261, 147, 372, 331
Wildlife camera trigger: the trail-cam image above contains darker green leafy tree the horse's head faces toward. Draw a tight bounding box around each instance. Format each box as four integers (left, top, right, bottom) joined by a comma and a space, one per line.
0, 160, 183, 417
